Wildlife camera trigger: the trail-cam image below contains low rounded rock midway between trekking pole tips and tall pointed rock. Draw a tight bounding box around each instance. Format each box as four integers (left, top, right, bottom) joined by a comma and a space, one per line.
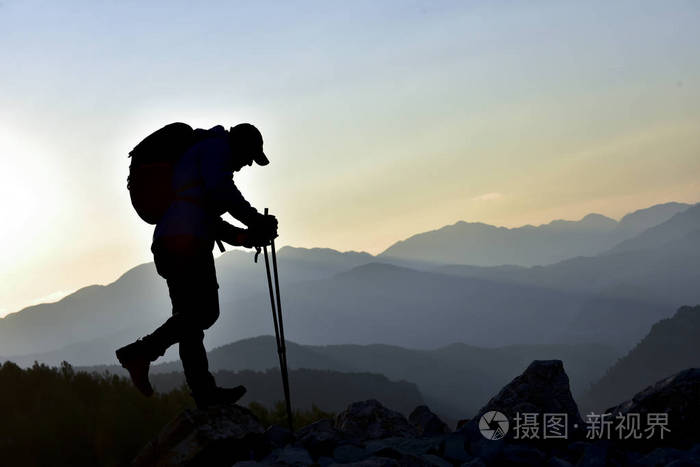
335, 399, 418, 440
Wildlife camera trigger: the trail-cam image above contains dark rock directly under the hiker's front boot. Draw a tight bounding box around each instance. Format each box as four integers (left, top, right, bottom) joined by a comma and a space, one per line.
133, 405, 269, 466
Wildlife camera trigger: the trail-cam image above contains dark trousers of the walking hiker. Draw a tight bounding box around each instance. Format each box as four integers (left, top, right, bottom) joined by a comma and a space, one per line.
144, 241, 219, 395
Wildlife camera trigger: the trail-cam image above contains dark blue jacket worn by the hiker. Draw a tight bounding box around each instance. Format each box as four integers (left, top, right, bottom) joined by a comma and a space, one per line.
153, 126, 262, 251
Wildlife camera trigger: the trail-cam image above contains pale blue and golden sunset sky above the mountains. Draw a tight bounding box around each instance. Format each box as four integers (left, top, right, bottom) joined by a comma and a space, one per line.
0, 0, 700, 316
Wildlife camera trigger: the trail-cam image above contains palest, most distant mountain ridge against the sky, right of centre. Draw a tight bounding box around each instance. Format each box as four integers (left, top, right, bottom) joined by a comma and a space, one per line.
378, 203, 690, 266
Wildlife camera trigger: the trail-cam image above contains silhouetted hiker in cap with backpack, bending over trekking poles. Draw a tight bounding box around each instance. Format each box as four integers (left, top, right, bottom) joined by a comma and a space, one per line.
116, 123, 277, 408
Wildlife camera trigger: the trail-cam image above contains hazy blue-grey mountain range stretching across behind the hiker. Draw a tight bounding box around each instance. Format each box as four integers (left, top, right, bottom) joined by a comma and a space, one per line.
0, 203, 700, 365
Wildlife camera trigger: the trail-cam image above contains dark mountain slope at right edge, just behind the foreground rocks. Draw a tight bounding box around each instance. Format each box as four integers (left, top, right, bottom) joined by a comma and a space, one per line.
584, 305, 700, 410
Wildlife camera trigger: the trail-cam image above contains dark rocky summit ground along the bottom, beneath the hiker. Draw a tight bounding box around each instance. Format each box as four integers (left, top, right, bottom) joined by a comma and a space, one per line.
134, 360, 700, 467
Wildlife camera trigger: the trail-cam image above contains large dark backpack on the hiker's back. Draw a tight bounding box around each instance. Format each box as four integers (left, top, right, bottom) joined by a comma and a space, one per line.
126, 123, 206, 224
